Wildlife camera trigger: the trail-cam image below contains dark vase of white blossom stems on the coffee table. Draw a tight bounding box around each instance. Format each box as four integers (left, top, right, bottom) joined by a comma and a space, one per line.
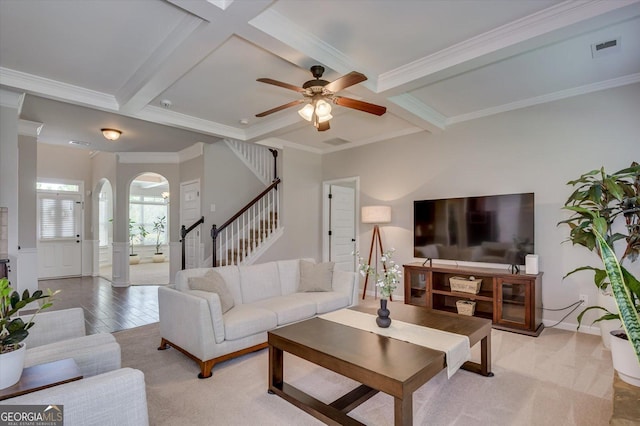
355, 249, 402, 328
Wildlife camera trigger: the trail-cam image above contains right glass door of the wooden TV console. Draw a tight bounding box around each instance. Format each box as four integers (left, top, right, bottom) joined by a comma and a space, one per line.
498, 279, 531, 328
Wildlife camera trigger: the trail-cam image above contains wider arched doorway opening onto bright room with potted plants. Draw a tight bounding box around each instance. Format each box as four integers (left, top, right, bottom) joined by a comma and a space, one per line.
129, 173, 170, 285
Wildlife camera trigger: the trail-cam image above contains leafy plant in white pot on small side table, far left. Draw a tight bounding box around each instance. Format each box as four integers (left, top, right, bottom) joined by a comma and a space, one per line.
0, 278, 60, 389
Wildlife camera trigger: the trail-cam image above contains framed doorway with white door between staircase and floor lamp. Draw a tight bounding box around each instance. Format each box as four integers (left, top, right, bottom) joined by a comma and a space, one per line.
322, 177, 360, 271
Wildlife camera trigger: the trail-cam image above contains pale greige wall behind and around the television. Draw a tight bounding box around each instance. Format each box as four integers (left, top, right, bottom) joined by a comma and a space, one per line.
322, 84, 640, 329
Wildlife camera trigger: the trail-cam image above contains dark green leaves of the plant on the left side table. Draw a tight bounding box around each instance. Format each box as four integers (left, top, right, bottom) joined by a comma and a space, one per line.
0, 278, 60, 354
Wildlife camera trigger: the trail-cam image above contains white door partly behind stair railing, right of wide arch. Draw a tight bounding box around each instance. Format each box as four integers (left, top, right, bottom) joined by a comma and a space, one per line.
180, 180, 202, 269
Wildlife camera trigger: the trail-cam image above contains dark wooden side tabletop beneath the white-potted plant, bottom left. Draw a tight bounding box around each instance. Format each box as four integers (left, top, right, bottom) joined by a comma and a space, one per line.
0, 358, 82, 400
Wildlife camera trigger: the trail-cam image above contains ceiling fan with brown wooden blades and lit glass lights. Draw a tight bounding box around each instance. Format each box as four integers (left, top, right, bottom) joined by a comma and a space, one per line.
256, 65, 387, 132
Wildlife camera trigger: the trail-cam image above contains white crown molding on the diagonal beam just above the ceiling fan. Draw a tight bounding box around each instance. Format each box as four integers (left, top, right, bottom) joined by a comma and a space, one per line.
249, 9, 377, 91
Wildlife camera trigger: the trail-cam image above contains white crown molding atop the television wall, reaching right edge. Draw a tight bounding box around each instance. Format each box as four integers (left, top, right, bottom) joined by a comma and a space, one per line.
447, 73, 640, 125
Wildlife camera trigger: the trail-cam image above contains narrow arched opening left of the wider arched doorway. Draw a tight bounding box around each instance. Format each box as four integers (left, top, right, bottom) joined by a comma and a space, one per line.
94, 179, 113, 281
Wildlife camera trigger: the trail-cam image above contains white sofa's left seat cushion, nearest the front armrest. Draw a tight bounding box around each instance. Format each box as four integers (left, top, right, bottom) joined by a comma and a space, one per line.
223, 304, 278, 340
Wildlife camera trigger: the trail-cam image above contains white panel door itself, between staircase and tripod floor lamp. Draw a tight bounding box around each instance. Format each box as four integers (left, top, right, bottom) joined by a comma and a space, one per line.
329, 185, 356, 271
